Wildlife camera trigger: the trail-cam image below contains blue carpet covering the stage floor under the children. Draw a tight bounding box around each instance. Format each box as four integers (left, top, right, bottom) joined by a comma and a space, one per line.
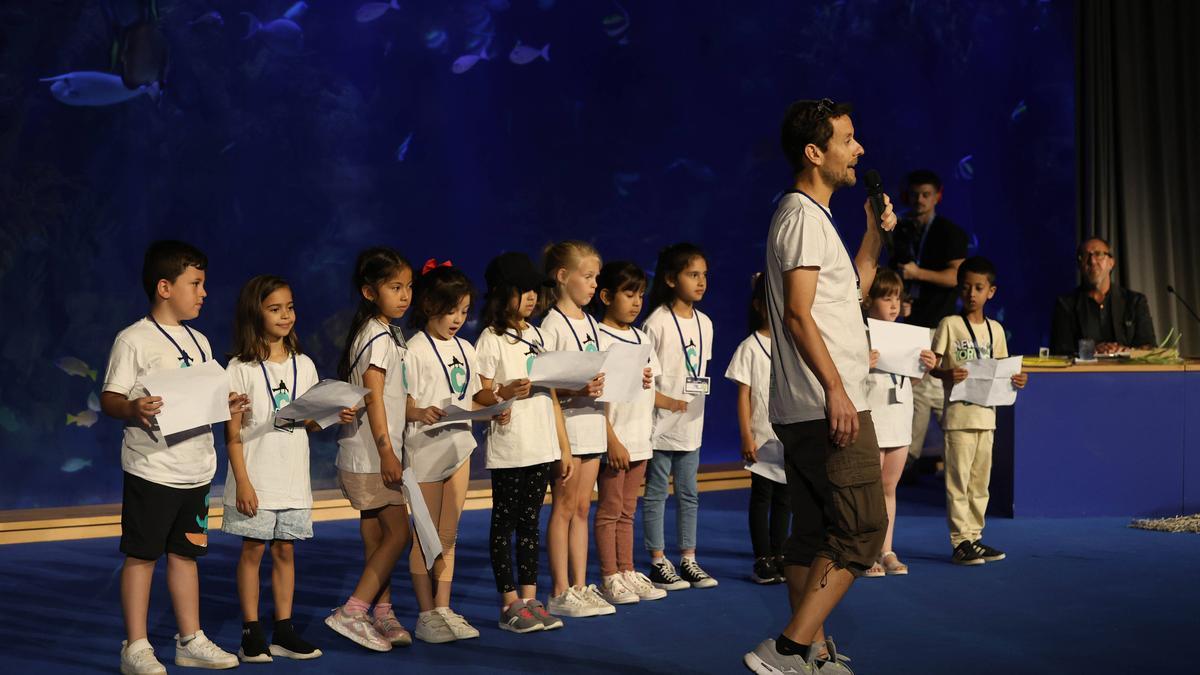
0, 475, 1200, 675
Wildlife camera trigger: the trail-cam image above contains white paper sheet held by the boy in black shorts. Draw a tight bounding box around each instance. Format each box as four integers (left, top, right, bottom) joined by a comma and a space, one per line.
142, 360, 229, 436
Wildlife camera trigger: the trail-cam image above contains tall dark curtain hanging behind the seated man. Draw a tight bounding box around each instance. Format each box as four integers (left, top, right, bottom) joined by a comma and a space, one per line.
1078, 0, 1200, 356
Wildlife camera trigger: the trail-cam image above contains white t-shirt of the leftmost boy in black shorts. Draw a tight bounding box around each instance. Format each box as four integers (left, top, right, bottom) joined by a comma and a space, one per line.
103, 318, 217, 489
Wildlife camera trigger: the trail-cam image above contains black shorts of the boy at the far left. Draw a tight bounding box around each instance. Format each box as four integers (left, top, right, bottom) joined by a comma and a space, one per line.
121, 472, 209, 560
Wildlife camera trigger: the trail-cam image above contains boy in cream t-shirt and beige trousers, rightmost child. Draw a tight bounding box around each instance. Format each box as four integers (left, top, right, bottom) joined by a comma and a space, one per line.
934, 256, 1028, 565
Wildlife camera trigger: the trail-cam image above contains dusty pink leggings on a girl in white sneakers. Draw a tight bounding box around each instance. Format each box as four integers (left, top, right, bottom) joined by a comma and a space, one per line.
595, 460, 646, 577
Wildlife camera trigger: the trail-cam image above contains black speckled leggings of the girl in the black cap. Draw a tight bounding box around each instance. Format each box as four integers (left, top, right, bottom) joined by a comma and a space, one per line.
491, 462, 553, 593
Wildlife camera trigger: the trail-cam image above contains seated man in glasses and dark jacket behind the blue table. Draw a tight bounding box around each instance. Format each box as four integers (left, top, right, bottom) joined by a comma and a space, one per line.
1050, 237, 1154, 354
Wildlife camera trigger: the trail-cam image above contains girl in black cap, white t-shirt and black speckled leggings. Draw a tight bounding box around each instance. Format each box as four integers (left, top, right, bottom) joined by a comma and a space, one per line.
475, 252, 575, 633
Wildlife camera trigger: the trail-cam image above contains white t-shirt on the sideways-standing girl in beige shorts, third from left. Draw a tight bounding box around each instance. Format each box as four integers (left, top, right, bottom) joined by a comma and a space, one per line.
337, 318, 408, 473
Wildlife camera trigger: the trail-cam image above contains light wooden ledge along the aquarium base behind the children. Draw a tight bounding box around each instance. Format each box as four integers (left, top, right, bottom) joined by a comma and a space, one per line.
0, 462, 750, 544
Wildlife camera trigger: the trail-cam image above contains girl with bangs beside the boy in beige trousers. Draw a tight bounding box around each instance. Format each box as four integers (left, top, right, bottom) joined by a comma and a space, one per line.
863, 268, 937, 577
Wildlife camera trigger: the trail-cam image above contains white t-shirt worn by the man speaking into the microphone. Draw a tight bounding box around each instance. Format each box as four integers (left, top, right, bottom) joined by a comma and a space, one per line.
767, 192, 870, 424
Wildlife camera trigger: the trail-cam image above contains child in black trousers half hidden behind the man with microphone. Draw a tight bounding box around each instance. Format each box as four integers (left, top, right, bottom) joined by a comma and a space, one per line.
725, 274, 792, 584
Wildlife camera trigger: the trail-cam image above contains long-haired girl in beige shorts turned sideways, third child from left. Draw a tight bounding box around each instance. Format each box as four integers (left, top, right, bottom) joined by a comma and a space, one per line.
325, 247, 413, 651
